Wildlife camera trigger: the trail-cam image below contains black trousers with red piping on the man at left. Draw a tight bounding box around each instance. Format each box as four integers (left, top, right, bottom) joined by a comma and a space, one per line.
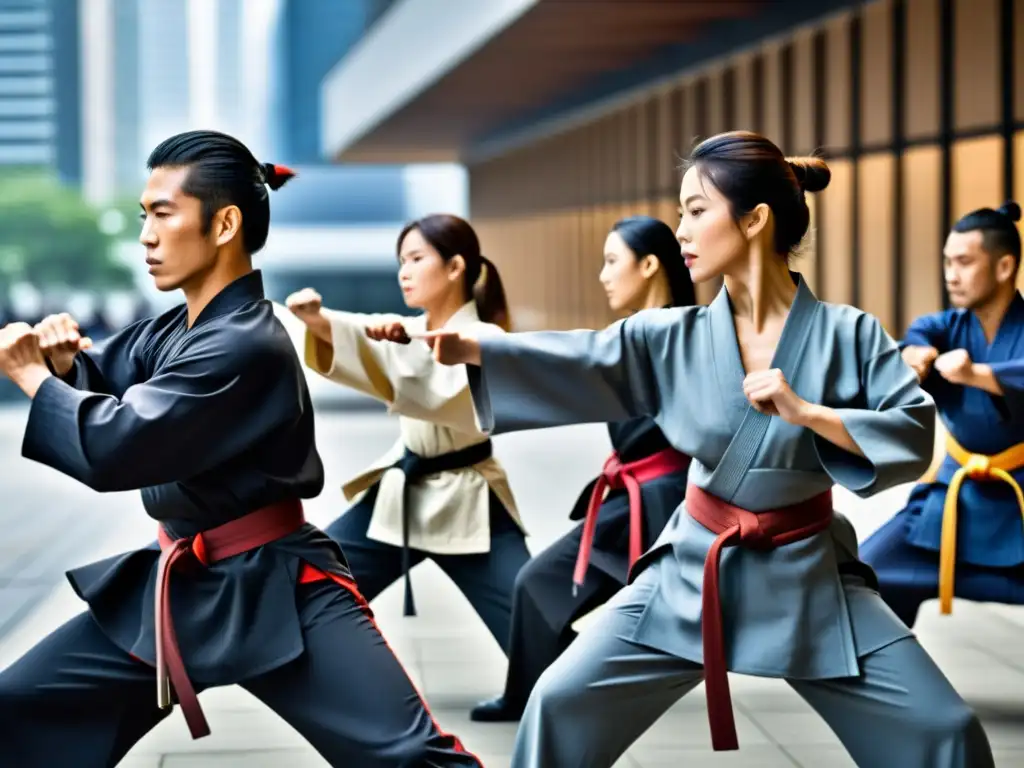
0, 582, 481, 768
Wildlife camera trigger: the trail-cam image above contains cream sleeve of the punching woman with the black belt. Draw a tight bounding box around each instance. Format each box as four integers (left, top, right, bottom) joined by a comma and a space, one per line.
304, 310, 489, 433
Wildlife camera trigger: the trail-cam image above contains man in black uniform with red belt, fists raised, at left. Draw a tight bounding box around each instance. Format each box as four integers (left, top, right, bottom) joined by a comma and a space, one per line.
0, 131, 480, 768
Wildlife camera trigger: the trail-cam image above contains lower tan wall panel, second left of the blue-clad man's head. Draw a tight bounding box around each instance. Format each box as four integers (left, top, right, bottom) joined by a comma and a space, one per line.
857, 153, 896, 334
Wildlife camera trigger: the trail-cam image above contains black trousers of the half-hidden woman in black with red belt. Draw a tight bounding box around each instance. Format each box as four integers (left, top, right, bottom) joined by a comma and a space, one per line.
495, 523, 623, 712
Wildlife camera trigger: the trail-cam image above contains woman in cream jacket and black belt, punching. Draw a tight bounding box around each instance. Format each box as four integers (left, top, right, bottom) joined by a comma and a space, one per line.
287, 214, 529, 651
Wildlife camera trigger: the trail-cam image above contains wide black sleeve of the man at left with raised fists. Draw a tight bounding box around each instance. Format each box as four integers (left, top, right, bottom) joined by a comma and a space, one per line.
22, 334, 302, 492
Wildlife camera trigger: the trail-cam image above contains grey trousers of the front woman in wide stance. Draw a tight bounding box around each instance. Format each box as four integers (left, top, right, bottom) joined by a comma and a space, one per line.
512, 585, 995, 768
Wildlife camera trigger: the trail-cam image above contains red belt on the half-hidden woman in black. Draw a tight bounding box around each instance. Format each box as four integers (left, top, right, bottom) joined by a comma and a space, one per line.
572, 449, 690, 592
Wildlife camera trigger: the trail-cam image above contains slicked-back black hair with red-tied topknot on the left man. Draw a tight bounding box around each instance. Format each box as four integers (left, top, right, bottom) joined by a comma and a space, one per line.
146, 131, 295, 255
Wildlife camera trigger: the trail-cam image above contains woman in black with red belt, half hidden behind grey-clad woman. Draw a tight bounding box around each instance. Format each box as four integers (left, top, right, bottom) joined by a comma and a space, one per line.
470, 216, 694, 722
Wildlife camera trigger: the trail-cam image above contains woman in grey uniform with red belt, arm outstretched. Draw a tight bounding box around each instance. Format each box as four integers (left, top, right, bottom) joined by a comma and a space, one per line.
405, 132, 993, 768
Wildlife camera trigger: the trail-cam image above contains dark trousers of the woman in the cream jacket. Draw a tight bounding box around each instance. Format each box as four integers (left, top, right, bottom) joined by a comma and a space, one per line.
325, 485, 529, 653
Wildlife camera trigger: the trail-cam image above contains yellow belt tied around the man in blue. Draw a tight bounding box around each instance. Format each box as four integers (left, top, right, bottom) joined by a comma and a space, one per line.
939, 434, 1024, 613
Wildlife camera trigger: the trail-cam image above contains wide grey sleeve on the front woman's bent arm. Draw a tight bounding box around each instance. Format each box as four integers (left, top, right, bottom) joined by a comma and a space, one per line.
814, 314, 935, 498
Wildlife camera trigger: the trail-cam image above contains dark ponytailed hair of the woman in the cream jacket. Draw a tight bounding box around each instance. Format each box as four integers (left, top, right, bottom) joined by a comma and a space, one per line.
397, 213, 512, 331
